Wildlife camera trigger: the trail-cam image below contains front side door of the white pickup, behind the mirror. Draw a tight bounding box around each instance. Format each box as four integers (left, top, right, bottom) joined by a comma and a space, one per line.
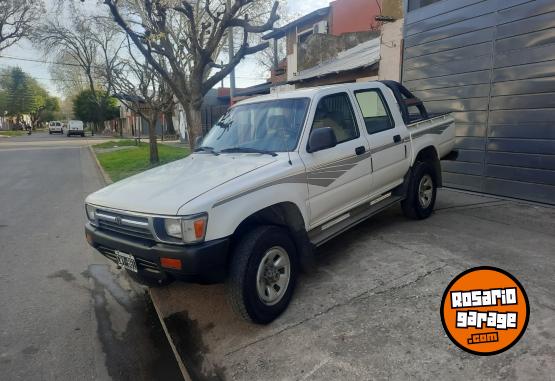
301, 92, 370, 227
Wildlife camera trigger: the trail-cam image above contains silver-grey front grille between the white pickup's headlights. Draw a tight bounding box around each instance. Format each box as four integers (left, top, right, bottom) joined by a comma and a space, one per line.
96, 209, 154, 241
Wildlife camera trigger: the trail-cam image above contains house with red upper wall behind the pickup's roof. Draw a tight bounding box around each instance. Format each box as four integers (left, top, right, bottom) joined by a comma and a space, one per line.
263, 0, 403, 87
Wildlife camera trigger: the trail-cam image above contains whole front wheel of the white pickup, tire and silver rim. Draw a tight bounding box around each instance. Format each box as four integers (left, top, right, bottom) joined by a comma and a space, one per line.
227, 226, 298, 324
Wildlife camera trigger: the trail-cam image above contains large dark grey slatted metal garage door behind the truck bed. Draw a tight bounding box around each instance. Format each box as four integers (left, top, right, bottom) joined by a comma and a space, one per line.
403, 0, 555, 204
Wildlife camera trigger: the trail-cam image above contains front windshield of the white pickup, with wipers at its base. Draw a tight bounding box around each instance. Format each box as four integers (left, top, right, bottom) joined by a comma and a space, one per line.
201, 98, 309, 152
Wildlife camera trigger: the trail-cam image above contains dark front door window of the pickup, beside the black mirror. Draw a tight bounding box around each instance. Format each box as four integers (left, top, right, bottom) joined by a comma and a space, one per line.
312, 93, 360, 144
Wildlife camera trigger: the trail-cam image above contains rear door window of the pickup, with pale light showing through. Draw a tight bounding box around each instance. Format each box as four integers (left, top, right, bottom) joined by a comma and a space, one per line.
355, 90, 394, 134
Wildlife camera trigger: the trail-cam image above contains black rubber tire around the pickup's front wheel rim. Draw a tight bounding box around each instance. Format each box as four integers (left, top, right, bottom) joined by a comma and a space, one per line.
227, 225, 299, 324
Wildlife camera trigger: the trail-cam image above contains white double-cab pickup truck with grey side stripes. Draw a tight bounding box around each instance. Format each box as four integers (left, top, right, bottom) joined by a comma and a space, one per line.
85, 81, 455, 324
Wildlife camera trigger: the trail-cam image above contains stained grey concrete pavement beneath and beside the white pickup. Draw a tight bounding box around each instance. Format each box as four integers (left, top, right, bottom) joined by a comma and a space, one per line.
151, 189, 555, 380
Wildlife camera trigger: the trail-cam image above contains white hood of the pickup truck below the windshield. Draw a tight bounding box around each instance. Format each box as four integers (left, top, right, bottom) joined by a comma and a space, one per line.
86, 153, 276, 215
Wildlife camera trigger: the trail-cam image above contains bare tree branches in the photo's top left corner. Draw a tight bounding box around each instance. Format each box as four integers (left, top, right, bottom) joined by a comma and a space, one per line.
0, 0, 43, 52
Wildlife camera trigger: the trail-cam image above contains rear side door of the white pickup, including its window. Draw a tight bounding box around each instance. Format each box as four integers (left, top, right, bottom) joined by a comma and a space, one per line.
354, 87, 410, 194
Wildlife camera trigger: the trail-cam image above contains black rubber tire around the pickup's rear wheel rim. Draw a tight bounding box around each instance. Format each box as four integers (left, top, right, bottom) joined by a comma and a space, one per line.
401, 162, 437, 220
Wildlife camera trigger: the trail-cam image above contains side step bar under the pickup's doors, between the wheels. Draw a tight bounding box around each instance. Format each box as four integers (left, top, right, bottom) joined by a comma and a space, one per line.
308, 192, 403, 246
